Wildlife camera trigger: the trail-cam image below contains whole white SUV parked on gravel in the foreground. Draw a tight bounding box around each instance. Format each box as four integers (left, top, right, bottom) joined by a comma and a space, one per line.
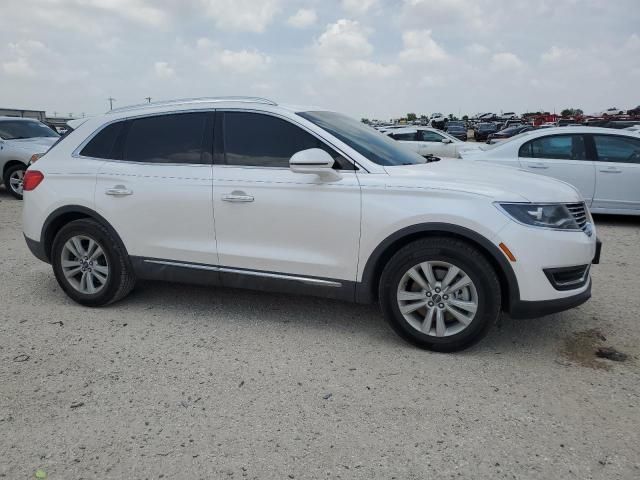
24, 98, 599, 351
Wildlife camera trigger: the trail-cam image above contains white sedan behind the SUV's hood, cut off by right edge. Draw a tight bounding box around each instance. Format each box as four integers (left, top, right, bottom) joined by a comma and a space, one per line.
462, 127, 640, 215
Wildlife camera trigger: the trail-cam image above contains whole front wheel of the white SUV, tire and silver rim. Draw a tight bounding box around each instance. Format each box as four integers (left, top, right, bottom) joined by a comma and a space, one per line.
379, 238, 501, 352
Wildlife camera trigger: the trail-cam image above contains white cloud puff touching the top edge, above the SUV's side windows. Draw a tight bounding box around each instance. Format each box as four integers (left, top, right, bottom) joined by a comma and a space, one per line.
202, 0, 281, 33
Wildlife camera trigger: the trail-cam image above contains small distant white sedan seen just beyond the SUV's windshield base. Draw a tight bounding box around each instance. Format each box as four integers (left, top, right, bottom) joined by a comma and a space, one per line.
385, 127, 480, 158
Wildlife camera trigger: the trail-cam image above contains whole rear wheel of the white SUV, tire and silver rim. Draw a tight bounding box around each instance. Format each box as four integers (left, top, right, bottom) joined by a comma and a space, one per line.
51, 219, 135, 307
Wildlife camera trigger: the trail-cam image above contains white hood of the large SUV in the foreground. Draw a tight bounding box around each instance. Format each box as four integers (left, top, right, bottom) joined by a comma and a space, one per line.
385, 159, 582, 203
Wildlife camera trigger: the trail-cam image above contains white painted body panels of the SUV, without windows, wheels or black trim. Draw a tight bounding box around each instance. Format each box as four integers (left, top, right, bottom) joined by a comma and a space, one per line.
24, 102, 596, 301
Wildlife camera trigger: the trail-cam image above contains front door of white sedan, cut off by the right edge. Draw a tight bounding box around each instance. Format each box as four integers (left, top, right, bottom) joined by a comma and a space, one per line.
593, 134, 640, 211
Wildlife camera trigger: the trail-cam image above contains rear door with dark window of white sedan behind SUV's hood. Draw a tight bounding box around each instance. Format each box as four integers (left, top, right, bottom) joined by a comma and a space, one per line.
518, 134, 596, 205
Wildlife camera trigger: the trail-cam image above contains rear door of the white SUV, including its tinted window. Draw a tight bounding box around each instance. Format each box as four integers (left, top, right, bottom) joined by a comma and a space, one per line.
95, 112, 217, 264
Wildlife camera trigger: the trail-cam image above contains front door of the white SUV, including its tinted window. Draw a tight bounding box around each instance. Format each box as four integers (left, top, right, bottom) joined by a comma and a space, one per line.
213, 111, 360, 283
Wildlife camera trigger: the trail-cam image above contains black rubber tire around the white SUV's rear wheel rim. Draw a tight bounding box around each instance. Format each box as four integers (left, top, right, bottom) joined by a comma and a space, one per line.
51, 219, 136, 307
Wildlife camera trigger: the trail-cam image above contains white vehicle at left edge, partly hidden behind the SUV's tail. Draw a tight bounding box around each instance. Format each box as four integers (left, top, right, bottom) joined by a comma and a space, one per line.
0, 117, 60, 199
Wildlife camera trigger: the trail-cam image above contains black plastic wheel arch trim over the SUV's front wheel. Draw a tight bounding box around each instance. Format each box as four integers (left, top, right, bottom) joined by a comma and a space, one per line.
356, 223, 520, 312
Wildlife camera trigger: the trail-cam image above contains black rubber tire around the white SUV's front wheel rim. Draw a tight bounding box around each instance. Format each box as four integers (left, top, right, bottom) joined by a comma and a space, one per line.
378, 237, 501, 352
